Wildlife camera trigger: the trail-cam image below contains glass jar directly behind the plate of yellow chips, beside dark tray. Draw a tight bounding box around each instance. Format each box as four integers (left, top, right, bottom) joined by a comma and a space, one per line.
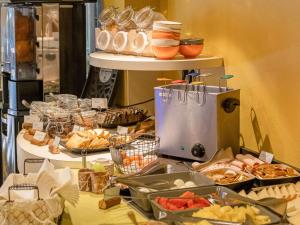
73, 110, 97, 129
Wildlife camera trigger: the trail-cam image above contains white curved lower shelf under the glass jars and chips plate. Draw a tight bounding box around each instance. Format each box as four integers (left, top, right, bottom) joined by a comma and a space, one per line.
17, 130, 111, 173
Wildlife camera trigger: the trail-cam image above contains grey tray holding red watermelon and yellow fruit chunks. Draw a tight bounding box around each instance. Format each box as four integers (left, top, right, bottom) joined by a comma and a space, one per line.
148, 186, 280, 223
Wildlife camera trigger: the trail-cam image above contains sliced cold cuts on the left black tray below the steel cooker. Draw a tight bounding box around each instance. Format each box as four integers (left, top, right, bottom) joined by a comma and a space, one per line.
203, 169, 253, 185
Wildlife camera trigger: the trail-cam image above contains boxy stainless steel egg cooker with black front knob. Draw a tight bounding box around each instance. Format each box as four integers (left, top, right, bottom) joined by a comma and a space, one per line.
154, 84, 240, 161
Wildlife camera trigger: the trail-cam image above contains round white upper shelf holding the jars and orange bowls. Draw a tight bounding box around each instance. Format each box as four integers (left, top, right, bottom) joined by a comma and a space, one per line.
90, 52, 224, 71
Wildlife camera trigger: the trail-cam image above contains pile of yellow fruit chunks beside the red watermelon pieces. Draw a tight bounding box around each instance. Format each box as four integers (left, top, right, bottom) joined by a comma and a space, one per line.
193, 204, 271, 225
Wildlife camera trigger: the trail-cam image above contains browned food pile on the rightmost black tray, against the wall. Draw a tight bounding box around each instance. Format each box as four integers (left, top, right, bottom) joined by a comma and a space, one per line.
252, 163, 300, 179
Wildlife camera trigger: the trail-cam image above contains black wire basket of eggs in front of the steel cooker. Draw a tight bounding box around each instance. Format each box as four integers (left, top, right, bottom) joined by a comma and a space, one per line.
110, 134, 160, 175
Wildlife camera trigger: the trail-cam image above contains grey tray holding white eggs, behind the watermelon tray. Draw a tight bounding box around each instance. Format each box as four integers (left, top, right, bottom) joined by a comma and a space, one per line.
129, 172, 214, 212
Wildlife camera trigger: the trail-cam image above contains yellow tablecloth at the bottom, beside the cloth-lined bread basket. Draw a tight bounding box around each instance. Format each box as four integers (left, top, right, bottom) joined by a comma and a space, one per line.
61, 192, 146, 225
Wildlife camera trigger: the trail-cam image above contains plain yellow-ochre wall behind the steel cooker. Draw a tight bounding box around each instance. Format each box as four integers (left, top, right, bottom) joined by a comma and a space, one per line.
166, 0, 300, 167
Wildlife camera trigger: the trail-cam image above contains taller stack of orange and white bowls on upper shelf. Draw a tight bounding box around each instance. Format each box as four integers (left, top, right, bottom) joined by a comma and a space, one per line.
151, 21, 182, 59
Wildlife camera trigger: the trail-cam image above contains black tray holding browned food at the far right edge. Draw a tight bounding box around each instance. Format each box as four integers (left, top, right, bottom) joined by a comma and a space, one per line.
255, 164, 300, 186
